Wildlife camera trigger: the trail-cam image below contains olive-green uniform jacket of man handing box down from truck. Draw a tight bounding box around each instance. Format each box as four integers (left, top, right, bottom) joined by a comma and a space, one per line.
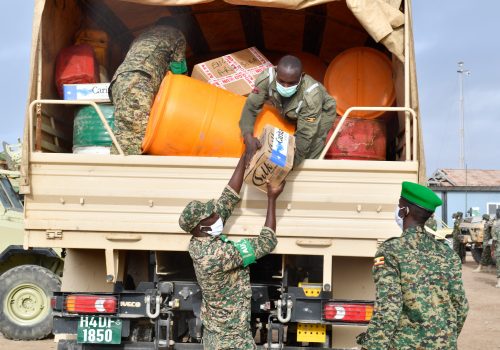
240, 70, 337, 166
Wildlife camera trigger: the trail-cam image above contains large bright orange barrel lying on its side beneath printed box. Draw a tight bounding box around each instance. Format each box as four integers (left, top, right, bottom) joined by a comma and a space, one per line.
142, 74, 295, 157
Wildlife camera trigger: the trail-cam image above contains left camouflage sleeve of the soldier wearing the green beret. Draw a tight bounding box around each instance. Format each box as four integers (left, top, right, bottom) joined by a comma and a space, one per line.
361, 247, 403, 350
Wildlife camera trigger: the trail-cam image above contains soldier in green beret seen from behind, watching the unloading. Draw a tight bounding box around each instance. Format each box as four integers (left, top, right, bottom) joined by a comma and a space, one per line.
357, 182, 469, 350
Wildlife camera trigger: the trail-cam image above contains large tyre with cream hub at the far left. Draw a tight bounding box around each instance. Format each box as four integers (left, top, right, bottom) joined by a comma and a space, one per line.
0, 265, 61, 340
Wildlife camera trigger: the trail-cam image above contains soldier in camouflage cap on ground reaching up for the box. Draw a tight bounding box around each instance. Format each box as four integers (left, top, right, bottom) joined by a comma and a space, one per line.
179, 156, 284, 350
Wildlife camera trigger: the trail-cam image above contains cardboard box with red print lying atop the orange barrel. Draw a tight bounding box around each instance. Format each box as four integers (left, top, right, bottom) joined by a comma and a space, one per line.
191, 47, 273, 96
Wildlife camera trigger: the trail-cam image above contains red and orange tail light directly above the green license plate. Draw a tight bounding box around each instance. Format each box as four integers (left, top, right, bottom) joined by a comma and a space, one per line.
65, 295, 118, 314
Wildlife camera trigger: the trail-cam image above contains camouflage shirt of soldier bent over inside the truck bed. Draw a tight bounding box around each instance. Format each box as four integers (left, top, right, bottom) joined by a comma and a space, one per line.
111, 25, 186, 90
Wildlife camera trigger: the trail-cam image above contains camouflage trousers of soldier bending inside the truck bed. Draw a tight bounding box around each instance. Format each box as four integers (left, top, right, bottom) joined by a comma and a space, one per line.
111, 71, 157, 155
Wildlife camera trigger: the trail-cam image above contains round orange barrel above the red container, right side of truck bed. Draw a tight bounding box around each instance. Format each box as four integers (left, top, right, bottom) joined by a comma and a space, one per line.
324, 47, 396, 119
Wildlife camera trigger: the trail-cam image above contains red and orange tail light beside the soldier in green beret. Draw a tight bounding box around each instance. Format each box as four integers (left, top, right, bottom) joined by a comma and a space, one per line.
323, 302, 373, 323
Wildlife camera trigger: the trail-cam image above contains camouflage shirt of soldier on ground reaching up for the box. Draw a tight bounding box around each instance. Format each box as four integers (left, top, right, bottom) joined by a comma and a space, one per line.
189, 186, 277, 349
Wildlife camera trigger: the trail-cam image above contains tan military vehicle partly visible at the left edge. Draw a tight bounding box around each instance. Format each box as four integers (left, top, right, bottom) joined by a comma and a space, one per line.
0, 143, 63, 340
